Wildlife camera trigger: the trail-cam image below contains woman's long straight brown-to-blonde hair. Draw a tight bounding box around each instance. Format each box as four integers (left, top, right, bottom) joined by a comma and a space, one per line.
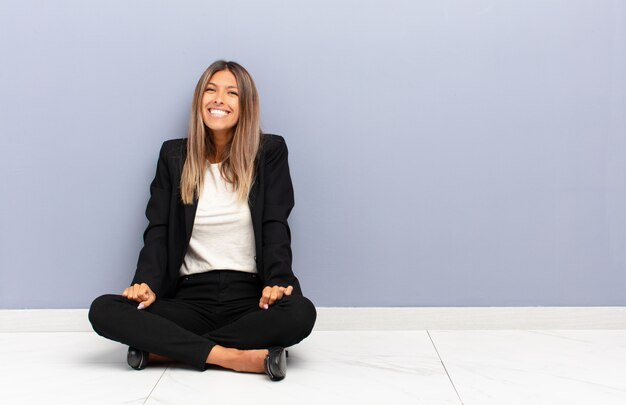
180, 60, 261, 204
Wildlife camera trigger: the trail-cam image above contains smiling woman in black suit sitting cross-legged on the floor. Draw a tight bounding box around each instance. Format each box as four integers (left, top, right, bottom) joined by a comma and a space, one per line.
89, 61, 316, 380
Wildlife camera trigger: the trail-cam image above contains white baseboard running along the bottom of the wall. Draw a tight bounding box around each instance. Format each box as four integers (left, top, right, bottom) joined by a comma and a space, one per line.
0, 307, 626, 333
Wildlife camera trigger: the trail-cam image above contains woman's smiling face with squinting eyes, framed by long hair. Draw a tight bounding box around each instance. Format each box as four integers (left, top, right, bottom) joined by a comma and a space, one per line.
202, 70, 239, 134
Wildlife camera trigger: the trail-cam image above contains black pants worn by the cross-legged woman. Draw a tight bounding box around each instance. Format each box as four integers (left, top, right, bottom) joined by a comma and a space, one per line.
89, 270, 316, 370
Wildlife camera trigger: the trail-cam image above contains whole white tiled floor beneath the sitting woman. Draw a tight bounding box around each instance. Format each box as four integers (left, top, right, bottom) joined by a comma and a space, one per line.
0, 330, 626, 405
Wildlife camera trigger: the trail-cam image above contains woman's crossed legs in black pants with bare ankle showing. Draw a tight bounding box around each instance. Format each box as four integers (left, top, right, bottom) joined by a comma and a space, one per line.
89, 288, 316, 372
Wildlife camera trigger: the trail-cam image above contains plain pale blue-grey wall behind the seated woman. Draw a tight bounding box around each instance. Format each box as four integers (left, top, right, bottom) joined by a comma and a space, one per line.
0, 0, 626, 308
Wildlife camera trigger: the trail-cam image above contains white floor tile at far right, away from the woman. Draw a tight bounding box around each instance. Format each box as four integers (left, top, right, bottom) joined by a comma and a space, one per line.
430, 330, 626, 405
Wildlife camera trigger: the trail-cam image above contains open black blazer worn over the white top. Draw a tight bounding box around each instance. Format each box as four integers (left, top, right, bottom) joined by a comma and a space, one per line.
132, 134, 302, 298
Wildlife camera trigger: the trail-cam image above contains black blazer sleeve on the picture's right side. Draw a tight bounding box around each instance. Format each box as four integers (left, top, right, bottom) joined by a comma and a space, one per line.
262, 136, 300, 291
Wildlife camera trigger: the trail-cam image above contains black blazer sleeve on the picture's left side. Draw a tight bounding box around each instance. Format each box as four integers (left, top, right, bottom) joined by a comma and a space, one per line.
132, 141, 172, 297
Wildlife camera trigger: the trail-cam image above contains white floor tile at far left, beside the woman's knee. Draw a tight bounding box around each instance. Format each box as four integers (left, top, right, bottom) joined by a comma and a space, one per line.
0, 332, 165, 405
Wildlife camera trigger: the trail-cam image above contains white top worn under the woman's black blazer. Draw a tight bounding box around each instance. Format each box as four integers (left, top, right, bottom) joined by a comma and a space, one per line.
180, 163, 257, 275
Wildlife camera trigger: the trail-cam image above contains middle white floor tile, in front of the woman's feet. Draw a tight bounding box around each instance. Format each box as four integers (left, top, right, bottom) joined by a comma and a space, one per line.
147, 331, 460, 405
